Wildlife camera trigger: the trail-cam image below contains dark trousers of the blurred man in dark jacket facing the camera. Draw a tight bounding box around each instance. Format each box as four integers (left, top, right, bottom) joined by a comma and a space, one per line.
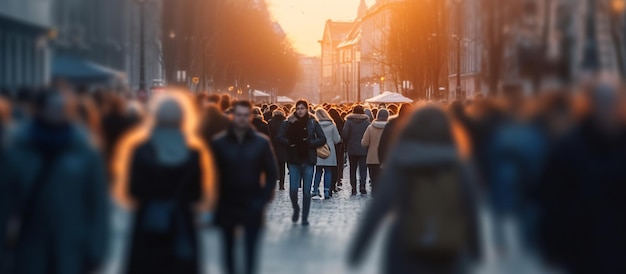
220, 225, 261, 274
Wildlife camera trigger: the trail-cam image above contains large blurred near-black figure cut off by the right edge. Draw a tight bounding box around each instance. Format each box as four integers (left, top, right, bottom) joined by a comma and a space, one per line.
540, 84, 626, 273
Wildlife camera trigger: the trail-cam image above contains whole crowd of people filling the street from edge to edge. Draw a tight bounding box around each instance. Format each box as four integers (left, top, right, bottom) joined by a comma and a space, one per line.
0, 79, 626, 274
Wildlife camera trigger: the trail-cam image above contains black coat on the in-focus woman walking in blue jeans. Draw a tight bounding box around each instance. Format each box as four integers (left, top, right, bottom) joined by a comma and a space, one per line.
276, 114, 326, 165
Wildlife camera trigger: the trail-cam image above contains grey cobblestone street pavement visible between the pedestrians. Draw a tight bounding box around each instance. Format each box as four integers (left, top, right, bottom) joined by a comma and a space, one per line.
106, 167, 383, 274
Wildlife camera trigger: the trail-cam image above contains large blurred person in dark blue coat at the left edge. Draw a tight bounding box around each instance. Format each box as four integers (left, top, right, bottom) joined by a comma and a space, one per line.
0, 90, 109, 274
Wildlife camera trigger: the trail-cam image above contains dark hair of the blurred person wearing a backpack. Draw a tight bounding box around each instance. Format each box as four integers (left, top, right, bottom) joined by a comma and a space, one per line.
400, 106, 454, 145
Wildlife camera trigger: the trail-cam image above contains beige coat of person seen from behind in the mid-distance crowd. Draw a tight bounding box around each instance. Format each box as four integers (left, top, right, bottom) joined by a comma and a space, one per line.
342, 114, 370, 156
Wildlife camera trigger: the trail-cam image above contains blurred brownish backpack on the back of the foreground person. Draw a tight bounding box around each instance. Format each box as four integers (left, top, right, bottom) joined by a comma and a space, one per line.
400, 167, 469, 257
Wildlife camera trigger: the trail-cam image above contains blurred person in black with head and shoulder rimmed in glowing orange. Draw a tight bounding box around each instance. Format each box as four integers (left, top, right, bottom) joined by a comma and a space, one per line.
126, 92, 213, 274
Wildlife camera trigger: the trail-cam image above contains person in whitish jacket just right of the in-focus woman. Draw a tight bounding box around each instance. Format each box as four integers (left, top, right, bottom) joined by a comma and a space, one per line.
312, 108, 341, 199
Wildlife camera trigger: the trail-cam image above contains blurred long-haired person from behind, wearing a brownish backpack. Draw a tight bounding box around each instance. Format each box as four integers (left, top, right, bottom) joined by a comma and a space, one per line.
349, 106, 477, 274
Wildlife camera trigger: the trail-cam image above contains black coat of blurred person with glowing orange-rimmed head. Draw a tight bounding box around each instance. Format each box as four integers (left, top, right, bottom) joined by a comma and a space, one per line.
128, 142, 202, 274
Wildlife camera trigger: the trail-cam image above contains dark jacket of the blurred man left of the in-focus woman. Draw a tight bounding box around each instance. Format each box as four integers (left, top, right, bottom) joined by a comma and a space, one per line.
212, 128, 278, 226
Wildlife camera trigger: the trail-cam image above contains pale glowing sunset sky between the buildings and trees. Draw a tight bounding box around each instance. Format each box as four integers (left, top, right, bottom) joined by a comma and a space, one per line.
267, 0, 375, 56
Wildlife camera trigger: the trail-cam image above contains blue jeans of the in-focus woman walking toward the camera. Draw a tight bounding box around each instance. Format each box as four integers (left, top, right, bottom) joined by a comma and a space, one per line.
287, 164, 314, 221
